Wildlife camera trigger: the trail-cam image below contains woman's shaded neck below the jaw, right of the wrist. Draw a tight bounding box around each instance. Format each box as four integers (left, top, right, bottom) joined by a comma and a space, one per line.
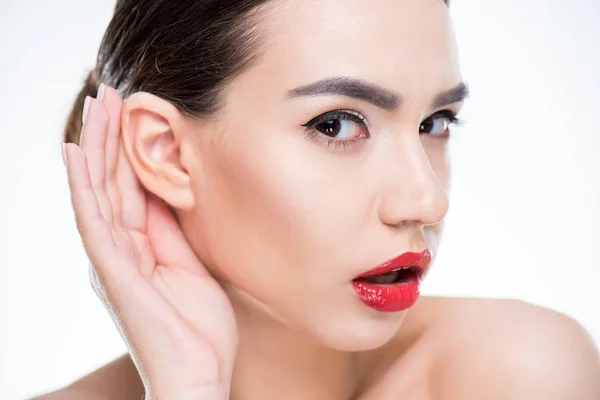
230, 295, 366, 400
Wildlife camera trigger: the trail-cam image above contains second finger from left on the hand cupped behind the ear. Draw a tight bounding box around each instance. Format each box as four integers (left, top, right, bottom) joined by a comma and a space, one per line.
80, 97, 113, 226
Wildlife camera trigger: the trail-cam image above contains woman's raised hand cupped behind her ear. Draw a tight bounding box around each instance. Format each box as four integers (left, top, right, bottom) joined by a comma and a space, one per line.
63, 87, 237, 400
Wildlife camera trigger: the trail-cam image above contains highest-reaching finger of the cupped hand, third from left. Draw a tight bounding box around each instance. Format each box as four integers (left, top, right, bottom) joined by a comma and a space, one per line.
99, 86, 123, 226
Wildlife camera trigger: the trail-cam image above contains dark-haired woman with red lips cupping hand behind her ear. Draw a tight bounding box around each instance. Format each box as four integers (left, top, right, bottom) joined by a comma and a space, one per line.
35, 0, 600, 400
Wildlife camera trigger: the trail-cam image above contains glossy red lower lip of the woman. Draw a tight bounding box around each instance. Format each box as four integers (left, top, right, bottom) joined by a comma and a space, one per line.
352, 275, 420, 312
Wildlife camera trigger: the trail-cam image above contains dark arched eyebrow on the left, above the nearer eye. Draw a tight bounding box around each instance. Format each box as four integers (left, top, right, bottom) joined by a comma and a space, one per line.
288, 76, 400, 111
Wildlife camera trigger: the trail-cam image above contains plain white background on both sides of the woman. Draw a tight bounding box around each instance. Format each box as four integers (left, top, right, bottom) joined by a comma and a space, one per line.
0, 0, 600, 400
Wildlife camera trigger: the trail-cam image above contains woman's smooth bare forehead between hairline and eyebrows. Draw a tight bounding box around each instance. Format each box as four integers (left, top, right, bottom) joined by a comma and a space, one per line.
248, 0, 460, 101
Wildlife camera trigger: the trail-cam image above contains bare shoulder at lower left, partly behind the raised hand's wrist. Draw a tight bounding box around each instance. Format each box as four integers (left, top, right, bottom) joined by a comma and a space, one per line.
32, 354, 144, 400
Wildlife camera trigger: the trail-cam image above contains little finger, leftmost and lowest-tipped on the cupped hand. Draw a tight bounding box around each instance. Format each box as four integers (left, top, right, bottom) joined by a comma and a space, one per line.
65, 143, 114, 265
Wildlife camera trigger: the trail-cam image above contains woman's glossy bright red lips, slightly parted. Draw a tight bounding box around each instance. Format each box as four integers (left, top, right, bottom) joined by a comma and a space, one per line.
352, 249, 431, 312
